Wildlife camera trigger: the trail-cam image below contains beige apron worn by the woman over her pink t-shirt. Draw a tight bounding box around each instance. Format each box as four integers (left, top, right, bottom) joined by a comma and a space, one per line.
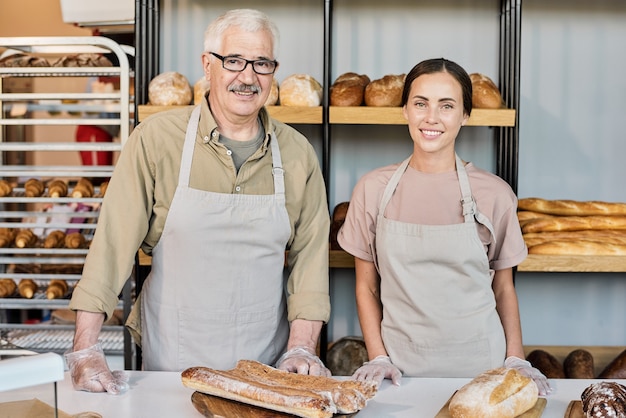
376, 156, 506, 377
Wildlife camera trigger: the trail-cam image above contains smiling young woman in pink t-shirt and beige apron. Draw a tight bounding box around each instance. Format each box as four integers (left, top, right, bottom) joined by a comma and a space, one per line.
338, 58, 549, 394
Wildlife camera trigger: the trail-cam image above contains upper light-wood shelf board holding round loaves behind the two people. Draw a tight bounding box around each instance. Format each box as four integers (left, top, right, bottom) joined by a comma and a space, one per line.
137, 105, 515, 126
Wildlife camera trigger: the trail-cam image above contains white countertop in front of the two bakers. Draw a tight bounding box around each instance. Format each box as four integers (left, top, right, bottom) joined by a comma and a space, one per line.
0, 371, 626, 418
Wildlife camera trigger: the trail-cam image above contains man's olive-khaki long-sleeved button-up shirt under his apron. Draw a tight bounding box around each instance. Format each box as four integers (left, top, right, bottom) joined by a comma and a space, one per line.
70, 100, 330, 322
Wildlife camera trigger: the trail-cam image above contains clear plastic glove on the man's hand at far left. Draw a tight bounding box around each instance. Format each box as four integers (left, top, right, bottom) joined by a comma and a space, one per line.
65, 343, 129, 395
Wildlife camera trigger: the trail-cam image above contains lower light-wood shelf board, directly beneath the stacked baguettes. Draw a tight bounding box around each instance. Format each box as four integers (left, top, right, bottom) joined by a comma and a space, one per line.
139, 250, 626, 273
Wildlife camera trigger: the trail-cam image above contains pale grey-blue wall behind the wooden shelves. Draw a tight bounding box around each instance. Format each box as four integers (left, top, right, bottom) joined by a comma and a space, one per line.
161, 0, 626, 345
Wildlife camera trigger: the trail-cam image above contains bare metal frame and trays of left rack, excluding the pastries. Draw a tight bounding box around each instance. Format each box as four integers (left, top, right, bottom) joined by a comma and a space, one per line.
0, 36, 134, 369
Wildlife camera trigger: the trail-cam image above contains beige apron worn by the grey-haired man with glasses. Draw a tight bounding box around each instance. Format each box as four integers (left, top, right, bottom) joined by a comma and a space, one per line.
141, 106, 290, 371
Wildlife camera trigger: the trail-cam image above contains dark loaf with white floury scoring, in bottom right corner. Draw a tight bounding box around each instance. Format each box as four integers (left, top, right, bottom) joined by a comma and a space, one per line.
580, 382, 626, 418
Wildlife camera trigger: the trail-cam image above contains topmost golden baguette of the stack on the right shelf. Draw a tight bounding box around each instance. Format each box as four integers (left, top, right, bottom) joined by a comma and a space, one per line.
517, 197, 626, 216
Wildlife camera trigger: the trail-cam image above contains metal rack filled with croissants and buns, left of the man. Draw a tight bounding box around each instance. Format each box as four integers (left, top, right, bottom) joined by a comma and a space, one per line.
0, 36, 134, 364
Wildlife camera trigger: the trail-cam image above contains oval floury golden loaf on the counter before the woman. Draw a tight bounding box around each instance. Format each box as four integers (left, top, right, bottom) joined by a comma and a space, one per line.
448, 367, 539, 418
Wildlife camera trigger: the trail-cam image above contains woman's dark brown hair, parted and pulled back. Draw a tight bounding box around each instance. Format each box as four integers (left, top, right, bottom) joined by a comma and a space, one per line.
402, 58, 472, 116
